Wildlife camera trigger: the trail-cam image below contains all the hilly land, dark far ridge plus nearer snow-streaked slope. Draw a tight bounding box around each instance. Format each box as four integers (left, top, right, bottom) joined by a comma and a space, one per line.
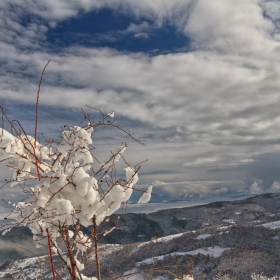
0, 194, 280, 280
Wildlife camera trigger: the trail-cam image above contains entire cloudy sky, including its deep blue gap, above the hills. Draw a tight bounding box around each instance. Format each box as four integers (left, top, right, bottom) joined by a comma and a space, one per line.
0, 0, 280, 212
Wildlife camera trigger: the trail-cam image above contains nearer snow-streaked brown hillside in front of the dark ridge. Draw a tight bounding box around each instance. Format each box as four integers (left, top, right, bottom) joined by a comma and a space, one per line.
0, 222, 280, 280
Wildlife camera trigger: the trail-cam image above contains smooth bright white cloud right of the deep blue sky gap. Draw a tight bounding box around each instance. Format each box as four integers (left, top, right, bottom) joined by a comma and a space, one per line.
184, 0, 276, 55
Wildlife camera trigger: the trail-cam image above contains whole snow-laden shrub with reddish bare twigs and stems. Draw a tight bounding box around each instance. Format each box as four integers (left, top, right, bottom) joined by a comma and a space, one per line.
0, 105, 151, 279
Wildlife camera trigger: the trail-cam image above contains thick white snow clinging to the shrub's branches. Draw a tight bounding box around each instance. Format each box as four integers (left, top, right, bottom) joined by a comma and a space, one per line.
0, 120, 151, 279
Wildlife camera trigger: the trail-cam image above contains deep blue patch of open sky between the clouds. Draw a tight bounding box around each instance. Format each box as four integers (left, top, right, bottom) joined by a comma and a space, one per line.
47, 8, 189, 53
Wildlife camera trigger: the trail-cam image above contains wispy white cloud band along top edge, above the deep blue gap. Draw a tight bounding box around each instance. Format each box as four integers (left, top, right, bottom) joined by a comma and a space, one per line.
0, 0, 192, 23
